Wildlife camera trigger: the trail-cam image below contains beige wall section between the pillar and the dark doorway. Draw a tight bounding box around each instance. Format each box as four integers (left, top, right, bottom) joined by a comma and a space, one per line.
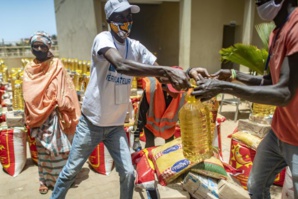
190, 0, 245, 72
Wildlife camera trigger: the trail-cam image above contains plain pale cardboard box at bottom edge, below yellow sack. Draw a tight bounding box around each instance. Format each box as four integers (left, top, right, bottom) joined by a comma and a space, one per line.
156, 183, 190, 199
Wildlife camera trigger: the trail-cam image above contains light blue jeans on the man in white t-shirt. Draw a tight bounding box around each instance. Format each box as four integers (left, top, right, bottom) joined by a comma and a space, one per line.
51, 115, 135, 199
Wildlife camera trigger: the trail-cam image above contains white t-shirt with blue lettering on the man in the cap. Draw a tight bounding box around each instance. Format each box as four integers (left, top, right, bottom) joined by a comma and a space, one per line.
82, 31, 156, 126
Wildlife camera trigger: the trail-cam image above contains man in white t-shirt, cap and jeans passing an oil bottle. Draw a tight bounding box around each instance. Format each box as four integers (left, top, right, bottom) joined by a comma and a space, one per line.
51, 0, 210, 199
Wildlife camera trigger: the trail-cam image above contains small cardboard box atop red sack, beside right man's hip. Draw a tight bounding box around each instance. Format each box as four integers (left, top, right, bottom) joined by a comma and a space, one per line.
237, 119, 271, 138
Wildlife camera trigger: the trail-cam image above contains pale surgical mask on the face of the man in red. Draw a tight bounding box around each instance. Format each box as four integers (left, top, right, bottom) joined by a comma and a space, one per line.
257, 0, 284, 21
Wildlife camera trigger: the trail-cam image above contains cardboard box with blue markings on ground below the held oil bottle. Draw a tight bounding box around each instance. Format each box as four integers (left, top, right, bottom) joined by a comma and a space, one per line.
183, 172, 219, 199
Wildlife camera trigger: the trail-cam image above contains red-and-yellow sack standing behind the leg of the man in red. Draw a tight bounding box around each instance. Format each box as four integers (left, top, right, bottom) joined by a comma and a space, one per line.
229, 131, 285, 189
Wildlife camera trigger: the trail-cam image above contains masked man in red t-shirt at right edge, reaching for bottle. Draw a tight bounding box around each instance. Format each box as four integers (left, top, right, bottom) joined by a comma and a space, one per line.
190, 0, 298, 199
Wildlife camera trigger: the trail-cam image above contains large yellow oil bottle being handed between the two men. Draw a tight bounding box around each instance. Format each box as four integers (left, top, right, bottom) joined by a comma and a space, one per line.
179, 92, 213, 162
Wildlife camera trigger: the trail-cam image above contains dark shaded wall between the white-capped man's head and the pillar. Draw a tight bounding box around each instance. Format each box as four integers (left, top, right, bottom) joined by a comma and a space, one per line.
130, 2, 179, 66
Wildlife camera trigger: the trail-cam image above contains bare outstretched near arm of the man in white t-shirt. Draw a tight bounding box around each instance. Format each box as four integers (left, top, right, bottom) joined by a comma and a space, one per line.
98, 48, 190, 90
